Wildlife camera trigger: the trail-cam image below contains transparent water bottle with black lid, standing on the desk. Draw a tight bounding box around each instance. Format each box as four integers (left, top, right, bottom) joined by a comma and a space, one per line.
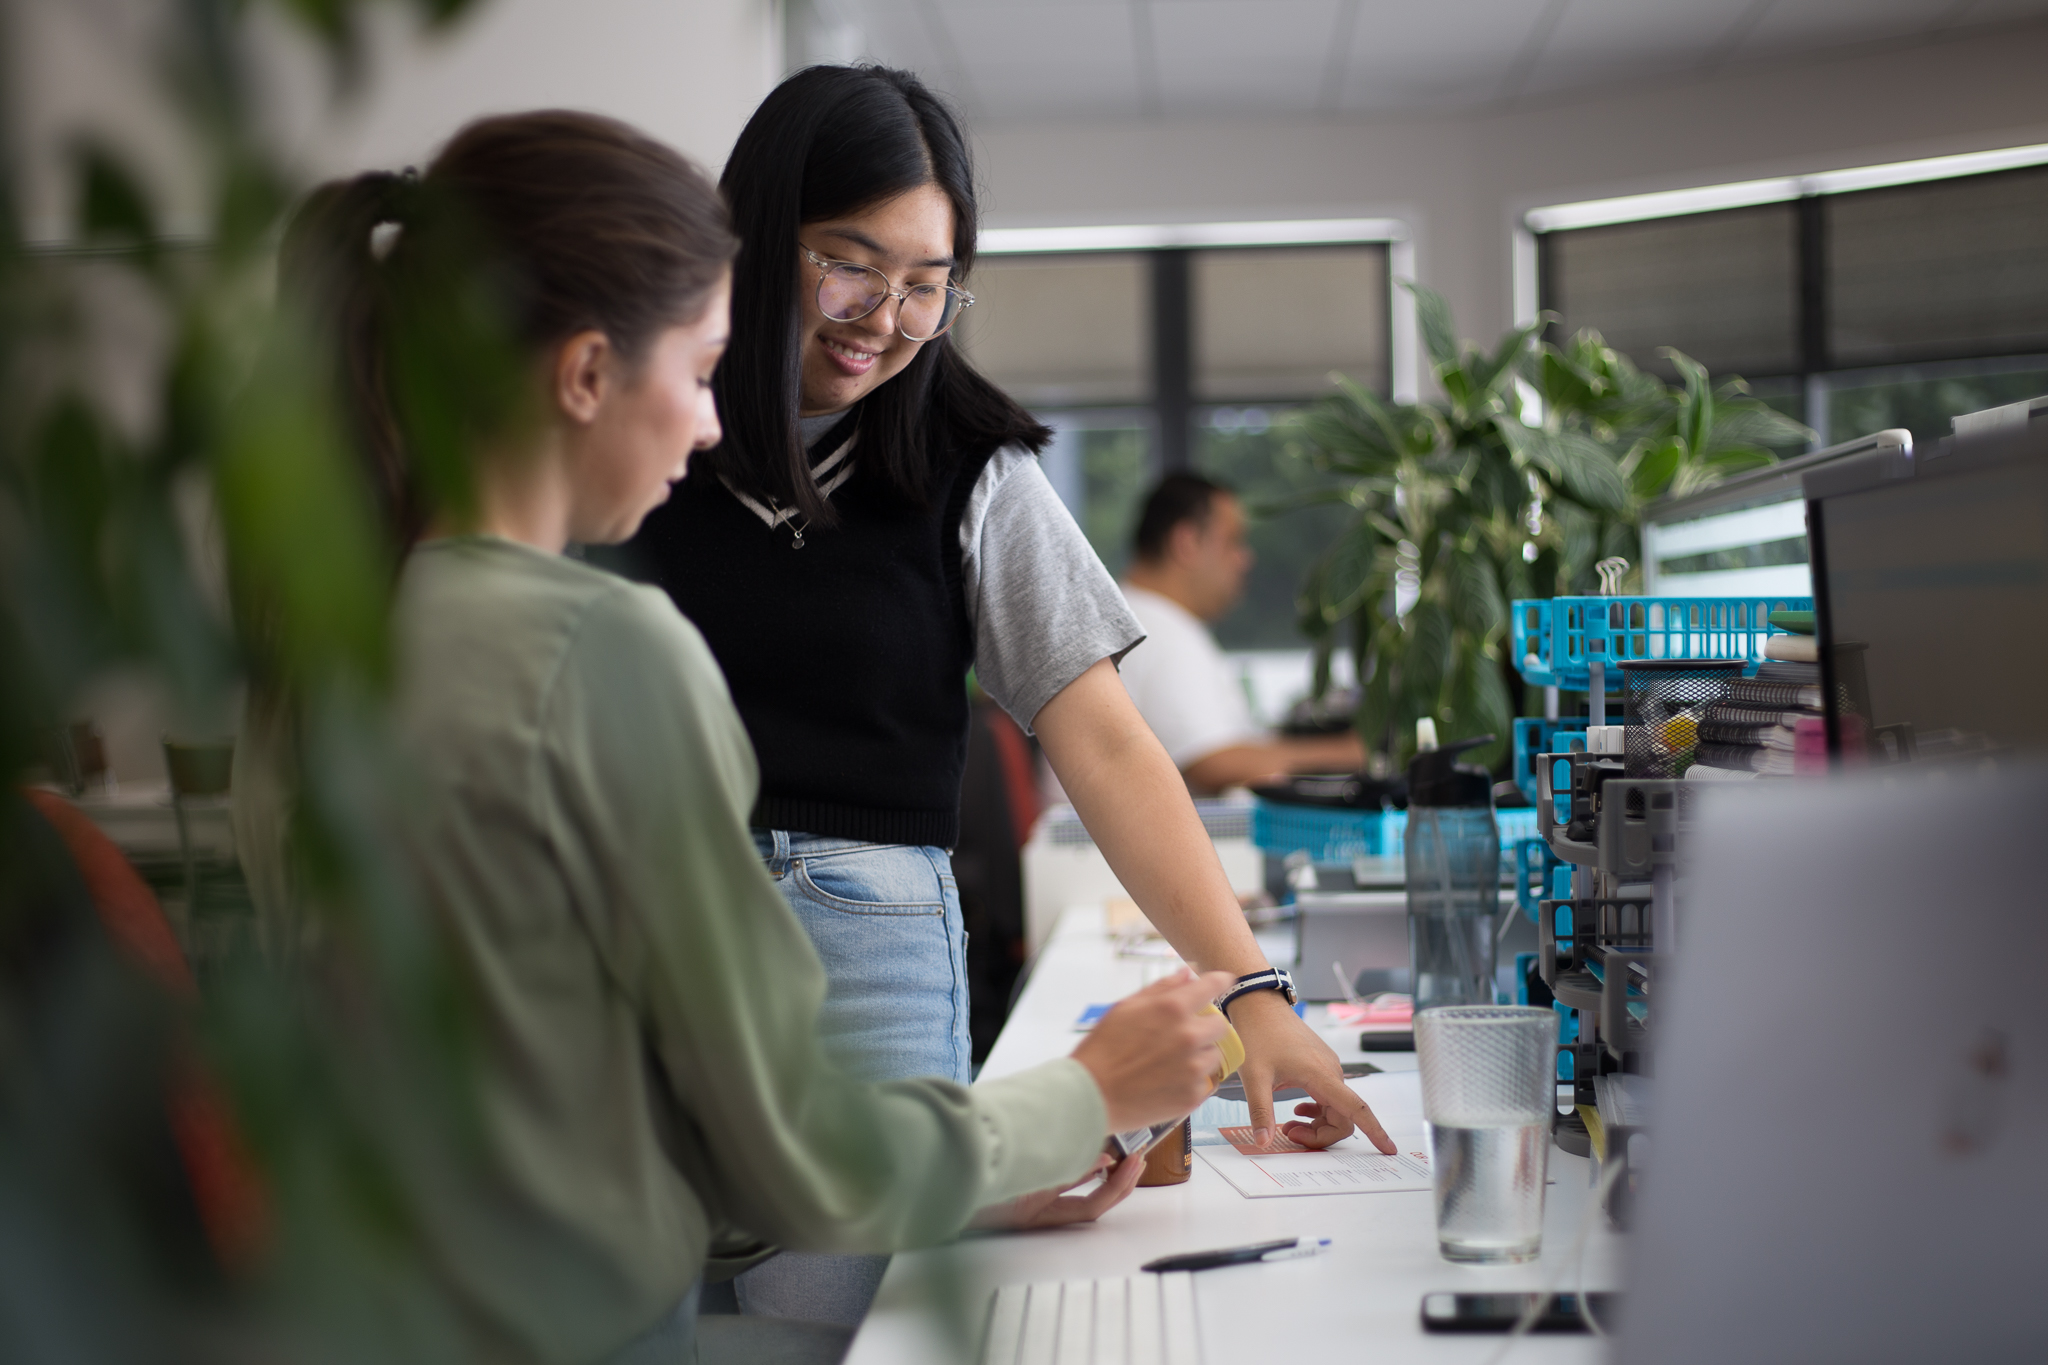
1407, 726, 1501, 1009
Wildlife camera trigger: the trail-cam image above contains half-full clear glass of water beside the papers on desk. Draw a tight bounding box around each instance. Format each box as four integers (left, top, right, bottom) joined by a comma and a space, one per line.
1415, 1005, 1556, 1265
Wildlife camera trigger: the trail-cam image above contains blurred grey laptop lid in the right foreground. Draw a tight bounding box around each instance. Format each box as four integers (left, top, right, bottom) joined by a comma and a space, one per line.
1616, 695, 2048, 1342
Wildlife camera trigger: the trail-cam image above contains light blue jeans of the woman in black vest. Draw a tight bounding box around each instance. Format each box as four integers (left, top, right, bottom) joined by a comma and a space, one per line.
733, 829, 971, 1326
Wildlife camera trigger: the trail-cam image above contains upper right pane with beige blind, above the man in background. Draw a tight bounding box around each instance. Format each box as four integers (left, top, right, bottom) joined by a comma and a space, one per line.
1190, 244, 1389, 401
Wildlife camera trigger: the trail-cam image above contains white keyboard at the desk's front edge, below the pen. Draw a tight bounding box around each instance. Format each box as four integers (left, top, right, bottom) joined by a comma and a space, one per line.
981, 1271, 1202, 1365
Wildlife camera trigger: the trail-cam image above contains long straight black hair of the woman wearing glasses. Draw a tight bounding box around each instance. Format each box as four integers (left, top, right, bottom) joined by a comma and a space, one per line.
698, 65, 1053, 526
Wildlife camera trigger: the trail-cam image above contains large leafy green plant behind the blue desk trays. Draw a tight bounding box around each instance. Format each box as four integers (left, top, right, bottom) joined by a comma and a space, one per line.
1294, 284, 1808, 763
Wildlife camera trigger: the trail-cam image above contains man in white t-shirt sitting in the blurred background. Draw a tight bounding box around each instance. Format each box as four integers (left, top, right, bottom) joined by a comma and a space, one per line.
1120, 475, 1366, 794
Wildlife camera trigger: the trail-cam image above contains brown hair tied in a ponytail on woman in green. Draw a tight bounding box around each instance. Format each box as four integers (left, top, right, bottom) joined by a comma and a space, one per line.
279, 111, 739, 555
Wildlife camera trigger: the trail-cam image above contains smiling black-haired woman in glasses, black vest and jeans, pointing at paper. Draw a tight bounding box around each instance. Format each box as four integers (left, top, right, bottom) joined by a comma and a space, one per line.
631, 68, 1393, 1322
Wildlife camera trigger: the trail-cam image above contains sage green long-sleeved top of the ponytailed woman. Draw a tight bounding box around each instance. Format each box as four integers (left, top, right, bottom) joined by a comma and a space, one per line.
366, 536, 1106, 1361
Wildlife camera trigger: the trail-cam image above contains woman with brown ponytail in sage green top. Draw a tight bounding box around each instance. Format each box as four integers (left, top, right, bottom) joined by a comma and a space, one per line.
249, 113, 1223, 1363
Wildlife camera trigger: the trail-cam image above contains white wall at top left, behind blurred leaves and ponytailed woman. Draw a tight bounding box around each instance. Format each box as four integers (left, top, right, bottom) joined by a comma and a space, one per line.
0, 0, 782, 239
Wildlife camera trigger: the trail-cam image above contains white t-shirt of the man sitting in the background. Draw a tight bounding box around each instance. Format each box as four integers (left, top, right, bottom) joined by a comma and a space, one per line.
1118, 583, 1268, 767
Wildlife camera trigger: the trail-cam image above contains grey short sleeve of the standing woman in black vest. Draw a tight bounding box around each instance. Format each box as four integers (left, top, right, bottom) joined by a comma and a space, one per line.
961, 446, 1145, 731
